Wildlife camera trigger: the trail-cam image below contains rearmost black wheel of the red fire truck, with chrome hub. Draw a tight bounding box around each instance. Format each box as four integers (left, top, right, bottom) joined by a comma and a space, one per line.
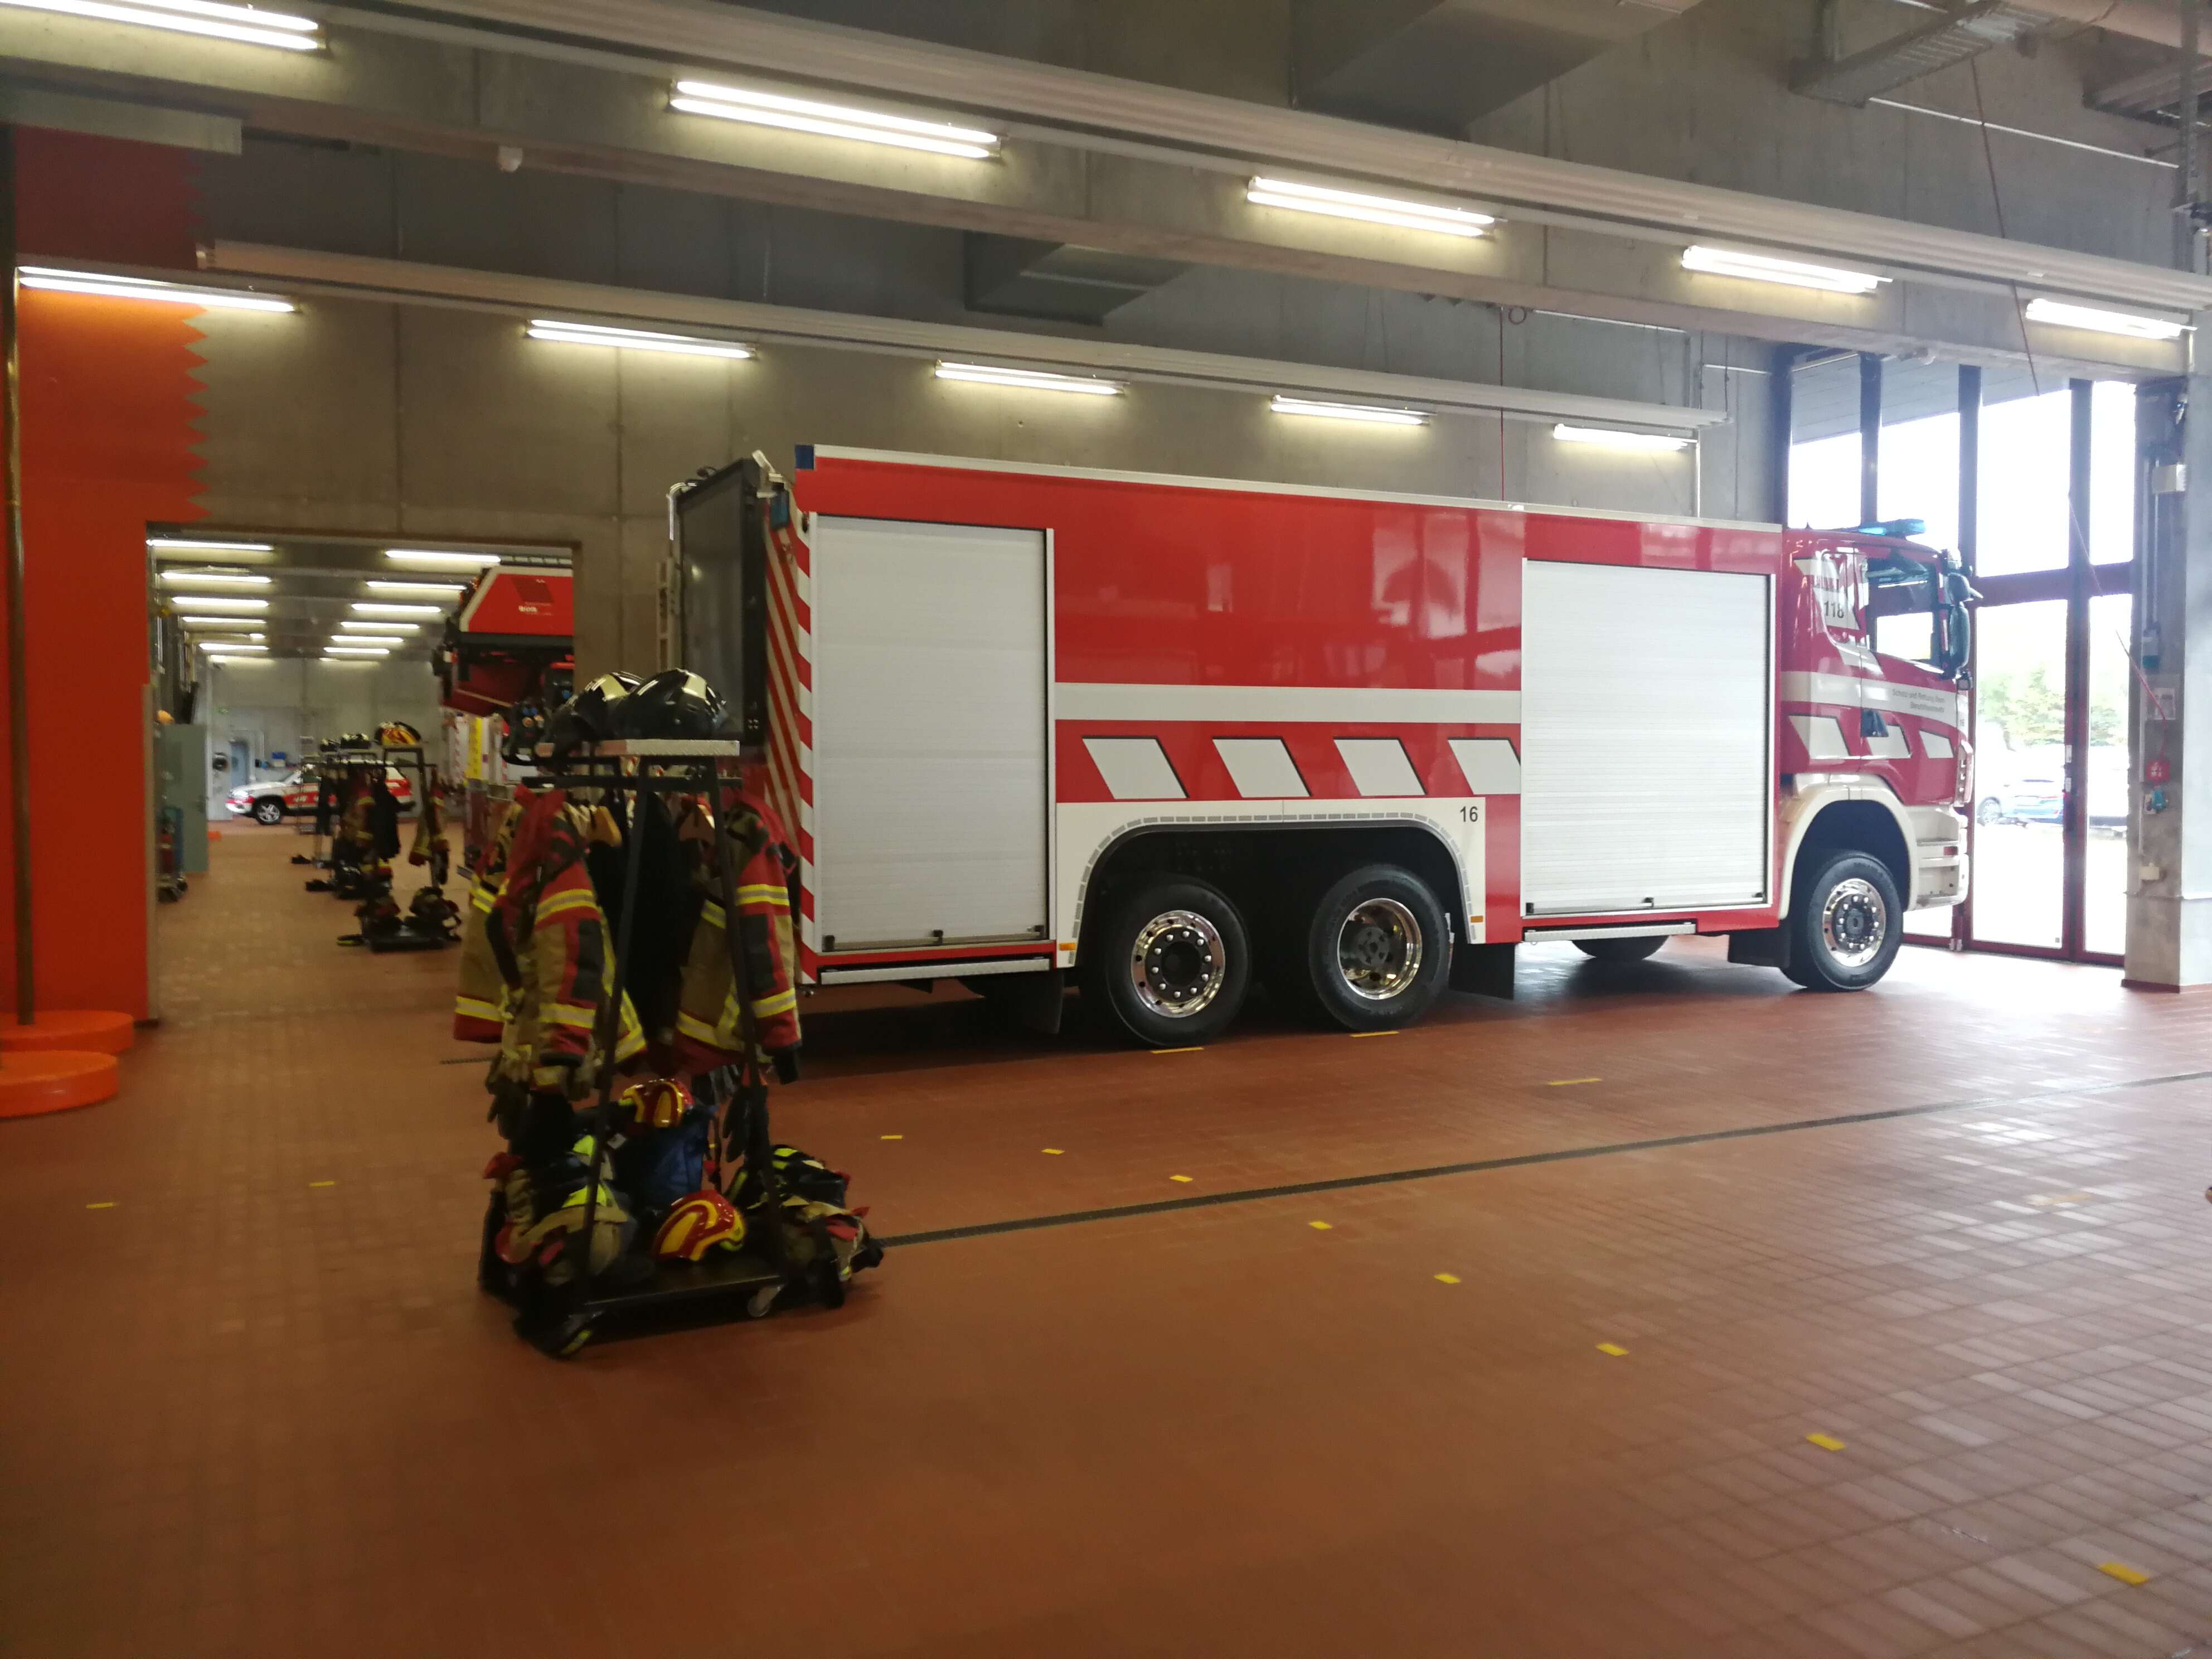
1084, 876, 1252, 1049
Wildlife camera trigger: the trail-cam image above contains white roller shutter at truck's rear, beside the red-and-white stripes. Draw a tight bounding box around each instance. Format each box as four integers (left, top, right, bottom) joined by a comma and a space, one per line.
812, 518, 1051, 951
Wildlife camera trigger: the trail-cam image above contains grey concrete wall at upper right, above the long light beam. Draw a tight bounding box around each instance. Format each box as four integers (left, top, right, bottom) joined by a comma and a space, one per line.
1469, 0, 2175, 265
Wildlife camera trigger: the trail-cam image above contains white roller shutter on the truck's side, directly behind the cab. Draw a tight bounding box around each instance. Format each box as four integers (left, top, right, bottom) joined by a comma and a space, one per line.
1522, 560, 1774, 916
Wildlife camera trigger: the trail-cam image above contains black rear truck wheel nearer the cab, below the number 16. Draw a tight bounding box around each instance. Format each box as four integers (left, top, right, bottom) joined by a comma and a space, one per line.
1305, 865, 1451, 1031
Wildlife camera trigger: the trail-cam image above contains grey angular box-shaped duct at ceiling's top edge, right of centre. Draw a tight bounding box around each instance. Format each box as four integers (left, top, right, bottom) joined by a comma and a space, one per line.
1292, 0, 1696, 137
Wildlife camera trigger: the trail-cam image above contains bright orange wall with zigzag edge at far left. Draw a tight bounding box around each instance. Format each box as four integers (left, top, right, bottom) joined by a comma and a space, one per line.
0, 128, 199, 1015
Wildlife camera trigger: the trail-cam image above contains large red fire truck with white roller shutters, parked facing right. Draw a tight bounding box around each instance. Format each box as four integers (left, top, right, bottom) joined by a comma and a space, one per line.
670, 447, 1973, 1046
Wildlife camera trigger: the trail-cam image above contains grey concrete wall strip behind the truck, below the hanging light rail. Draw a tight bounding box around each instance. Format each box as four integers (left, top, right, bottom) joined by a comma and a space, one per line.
181, 299, 1767, 672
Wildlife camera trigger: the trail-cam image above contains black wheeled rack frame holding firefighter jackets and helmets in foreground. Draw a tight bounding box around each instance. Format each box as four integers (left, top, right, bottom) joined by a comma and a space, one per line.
478, 739, 845, 1358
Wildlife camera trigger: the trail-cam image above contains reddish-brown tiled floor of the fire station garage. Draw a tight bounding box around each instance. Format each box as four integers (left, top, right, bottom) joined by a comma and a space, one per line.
0, 827, 2212, 1659
